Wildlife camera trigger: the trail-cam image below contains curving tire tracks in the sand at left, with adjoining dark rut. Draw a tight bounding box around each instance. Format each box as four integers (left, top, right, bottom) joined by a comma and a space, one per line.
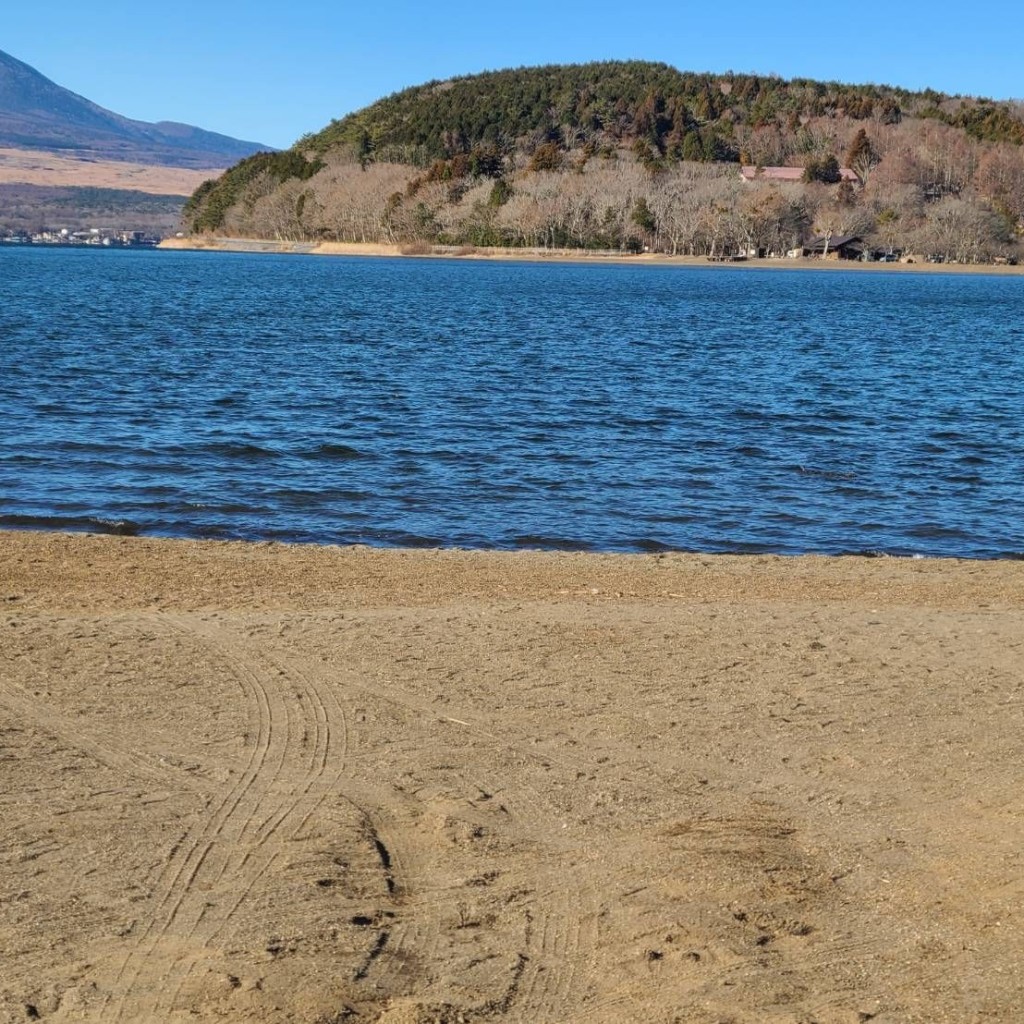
98, 615, 406, 1021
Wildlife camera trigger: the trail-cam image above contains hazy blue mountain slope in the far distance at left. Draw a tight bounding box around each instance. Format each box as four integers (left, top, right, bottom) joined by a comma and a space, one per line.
0, 50, 271, 168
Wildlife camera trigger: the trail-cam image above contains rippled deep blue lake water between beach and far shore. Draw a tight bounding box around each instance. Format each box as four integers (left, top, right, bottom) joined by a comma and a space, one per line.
0, 243, 1024, 558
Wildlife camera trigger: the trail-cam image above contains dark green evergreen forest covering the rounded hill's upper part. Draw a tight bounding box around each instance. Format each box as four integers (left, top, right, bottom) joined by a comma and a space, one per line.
302, 60, 1024, 163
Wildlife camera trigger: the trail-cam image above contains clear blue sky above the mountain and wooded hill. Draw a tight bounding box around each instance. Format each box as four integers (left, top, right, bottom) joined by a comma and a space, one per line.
0, 0, 1024, 146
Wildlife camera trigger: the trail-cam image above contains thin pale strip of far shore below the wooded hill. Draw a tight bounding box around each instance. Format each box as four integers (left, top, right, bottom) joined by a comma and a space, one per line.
158, 238, 1024, 276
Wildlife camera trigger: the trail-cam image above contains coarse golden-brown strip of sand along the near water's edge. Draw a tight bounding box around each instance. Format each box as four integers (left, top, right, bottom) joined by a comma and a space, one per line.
6, 527, 1024, 610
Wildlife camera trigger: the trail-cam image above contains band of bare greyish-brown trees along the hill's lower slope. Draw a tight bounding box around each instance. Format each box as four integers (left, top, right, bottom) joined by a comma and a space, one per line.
203, 143, 1024, 262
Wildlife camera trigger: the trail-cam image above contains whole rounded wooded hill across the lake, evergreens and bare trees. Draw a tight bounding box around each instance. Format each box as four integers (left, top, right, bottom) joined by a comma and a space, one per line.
185, 61, 1024, 259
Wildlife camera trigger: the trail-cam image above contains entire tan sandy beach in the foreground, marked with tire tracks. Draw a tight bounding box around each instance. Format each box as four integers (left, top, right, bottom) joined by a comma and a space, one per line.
0, 532, 1024, 1024
